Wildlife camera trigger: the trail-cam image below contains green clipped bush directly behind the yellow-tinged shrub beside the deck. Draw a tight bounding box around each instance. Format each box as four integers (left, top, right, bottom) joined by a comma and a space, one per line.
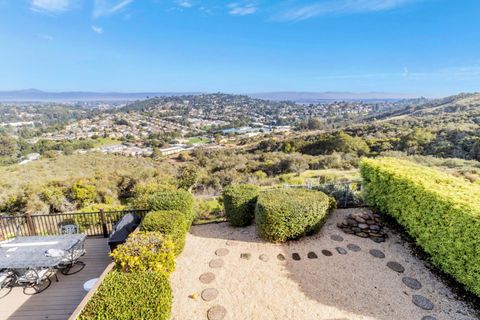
140, 211, 189, 255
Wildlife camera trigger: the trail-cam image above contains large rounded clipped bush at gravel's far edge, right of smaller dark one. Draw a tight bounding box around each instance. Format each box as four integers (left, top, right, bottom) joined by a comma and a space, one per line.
255, 189, 330, 242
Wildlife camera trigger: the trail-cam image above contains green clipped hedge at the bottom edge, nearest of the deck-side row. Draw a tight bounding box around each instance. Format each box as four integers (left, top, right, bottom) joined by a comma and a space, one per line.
79, 271, 172, 320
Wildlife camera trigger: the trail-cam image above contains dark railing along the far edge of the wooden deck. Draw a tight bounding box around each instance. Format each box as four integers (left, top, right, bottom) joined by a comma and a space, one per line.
0, 210, 148, 240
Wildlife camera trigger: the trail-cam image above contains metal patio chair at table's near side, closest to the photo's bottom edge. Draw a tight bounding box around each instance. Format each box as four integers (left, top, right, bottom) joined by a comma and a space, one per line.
16, 268, 58, 295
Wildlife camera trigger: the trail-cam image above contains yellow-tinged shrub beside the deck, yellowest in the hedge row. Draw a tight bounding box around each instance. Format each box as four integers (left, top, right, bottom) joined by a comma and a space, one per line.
110, 232, 175, 276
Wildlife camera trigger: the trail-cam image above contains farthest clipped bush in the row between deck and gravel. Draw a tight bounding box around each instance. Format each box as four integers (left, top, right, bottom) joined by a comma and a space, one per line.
146, 190, 195, 226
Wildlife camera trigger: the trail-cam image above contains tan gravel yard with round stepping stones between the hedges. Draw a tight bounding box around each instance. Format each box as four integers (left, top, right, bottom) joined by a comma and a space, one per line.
172, 209, 476, 320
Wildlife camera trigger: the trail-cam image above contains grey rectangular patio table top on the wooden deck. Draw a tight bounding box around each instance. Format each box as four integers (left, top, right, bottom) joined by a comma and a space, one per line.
0, 234, 86, 269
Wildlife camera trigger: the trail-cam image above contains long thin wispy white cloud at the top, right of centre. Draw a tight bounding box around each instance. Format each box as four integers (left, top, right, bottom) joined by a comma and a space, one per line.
276, 0, 422, 21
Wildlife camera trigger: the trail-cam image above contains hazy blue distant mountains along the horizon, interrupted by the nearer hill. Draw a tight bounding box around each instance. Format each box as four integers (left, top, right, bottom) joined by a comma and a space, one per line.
0, 89, 414, 103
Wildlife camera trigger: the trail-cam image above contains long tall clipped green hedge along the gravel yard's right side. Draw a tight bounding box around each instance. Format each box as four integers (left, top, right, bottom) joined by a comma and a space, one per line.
361, 158, 480, 296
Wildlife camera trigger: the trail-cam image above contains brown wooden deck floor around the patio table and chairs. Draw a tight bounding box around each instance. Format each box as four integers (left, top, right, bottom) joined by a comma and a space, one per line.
0, 238, 112, 320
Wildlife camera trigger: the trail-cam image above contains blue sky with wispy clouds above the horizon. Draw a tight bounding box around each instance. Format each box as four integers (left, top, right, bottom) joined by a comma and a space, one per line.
0, 0, 480, 96
